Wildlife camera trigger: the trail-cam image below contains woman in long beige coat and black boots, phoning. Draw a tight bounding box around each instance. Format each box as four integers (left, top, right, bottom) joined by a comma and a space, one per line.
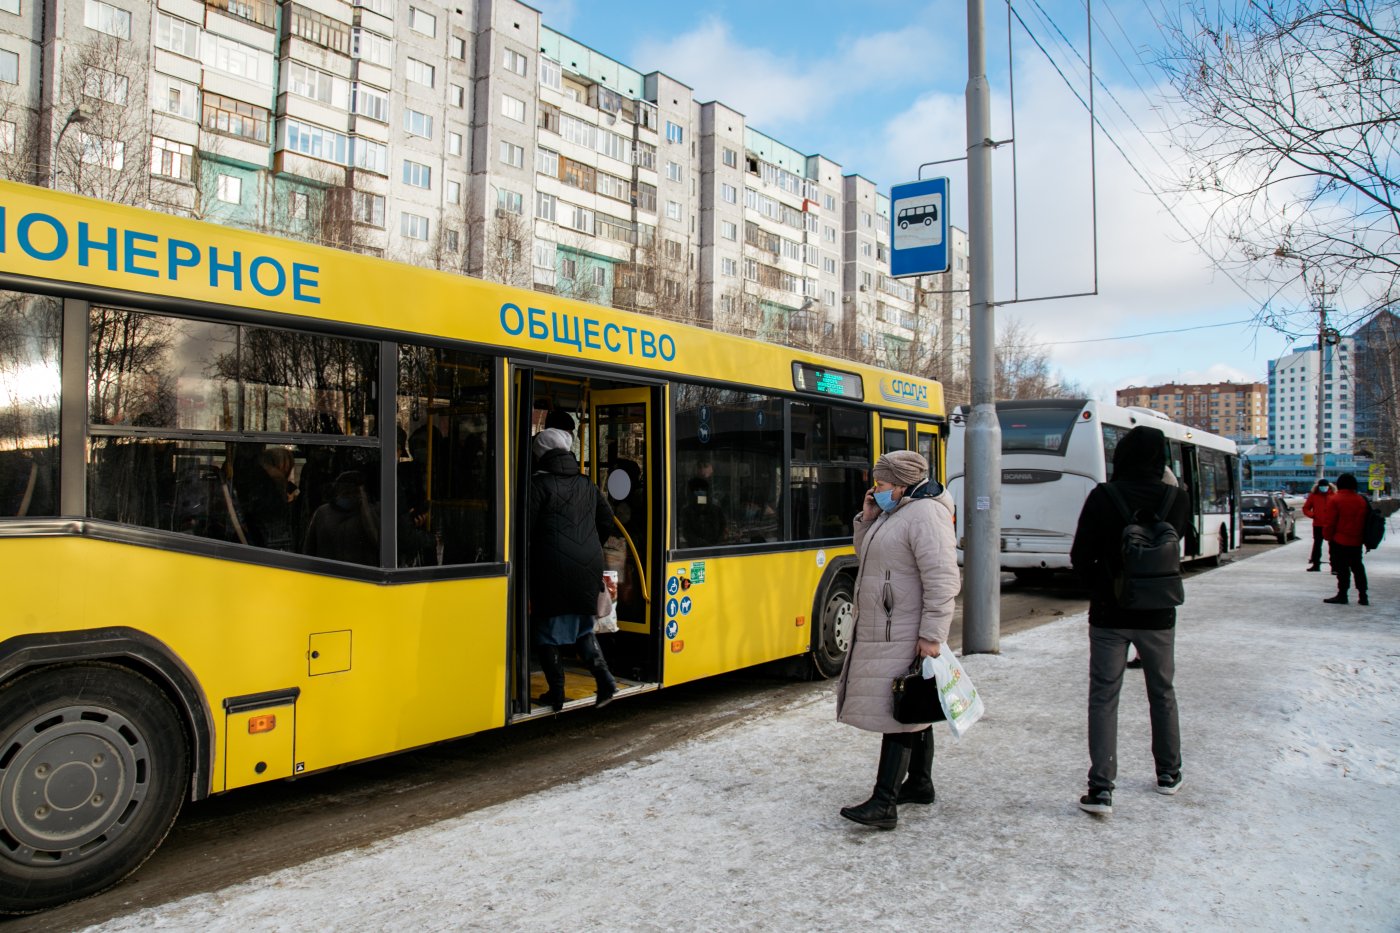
836, 450, 959, 829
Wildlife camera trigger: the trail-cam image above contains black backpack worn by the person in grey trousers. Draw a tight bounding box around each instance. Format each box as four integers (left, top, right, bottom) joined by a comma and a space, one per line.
1103, 483, 1186, 609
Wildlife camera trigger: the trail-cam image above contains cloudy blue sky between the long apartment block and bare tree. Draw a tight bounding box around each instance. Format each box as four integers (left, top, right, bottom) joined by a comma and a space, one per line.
532, 0, 1344, 401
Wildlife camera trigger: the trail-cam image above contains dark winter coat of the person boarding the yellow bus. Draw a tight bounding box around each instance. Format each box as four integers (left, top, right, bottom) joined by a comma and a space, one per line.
529, 450, 613, 618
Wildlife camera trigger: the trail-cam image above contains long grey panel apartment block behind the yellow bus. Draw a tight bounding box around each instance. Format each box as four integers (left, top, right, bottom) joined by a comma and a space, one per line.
0, 0, 967, 378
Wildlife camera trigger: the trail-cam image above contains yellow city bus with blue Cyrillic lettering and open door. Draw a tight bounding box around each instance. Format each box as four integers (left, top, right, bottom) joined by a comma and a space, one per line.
0, 184, 946, 912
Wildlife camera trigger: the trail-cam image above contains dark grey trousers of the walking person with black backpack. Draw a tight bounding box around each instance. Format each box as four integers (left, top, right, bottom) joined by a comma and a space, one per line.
1089, 625, 1182, 790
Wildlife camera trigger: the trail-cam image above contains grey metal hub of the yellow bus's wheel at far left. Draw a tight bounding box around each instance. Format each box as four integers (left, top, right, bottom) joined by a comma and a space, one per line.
0, 706, 150, 866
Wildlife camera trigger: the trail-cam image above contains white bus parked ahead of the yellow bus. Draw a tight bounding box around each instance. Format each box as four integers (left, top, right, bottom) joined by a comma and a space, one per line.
948, 398, 1239, 580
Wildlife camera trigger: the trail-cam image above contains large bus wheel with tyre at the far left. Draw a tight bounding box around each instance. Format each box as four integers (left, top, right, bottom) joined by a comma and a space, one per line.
0, 664, 190, 913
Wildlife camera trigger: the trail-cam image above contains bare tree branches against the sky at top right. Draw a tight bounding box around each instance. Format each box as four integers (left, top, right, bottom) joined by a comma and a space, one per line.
1161, 0, 1400, 325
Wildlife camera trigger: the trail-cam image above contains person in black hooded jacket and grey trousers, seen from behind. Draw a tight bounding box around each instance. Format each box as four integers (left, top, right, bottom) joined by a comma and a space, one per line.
1070, 424, 1190, 814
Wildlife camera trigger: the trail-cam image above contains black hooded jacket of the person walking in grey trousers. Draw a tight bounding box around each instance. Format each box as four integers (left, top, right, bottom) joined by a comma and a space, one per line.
1070, 424, 1191, 629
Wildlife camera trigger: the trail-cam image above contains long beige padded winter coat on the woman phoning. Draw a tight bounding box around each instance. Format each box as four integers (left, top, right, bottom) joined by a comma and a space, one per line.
836, 482, 959, 733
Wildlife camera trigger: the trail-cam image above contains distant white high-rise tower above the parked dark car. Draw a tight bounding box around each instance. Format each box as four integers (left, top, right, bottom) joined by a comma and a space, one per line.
1268, 336, 1357, 454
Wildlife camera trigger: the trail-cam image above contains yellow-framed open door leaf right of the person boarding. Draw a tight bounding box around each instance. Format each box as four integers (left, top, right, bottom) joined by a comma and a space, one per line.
589, 388, 662, 669
